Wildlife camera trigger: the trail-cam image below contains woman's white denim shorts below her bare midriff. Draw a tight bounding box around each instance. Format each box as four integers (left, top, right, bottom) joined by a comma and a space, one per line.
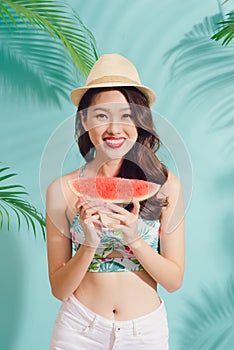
50, 295, 168, 350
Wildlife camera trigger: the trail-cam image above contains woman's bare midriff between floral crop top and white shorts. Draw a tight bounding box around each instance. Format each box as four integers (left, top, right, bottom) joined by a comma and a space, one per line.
74, 252, 160, 321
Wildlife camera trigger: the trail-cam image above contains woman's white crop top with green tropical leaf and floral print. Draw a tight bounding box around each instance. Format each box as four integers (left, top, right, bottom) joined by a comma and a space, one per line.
70, 165, 160, 272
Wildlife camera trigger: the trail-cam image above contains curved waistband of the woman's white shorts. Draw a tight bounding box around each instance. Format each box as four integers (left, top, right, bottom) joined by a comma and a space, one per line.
64, 294, 166, 330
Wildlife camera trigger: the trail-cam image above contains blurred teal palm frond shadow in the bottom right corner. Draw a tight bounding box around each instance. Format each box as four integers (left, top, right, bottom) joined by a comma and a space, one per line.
176, 275, 234, 350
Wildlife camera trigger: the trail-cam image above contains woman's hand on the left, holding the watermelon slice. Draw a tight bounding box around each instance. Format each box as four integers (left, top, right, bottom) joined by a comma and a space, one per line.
76, 197, 103, 248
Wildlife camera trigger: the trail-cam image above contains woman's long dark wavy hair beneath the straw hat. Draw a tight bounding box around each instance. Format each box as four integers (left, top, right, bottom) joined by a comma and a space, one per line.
75, 87, 168, 220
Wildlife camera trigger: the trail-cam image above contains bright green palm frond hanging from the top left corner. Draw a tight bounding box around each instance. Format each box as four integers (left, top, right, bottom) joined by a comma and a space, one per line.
2, 0, 97, 75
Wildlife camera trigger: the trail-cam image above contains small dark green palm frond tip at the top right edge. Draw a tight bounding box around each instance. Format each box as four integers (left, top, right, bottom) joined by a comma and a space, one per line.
211, 12, 234, 45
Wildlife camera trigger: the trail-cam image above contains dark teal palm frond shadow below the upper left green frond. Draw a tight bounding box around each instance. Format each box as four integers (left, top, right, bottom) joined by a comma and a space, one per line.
0, 27, 76, 106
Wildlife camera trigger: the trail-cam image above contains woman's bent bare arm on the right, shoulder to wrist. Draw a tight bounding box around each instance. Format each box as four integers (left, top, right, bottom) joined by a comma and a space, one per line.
130, 172, 184, 292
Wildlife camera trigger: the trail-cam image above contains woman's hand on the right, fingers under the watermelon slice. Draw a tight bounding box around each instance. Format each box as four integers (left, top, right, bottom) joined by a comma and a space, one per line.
106, 198, 140, 245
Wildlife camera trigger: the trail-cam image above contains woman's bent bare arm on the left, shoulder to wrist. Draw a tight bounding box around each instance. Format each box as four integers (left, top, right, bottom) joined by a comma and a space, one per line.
46, 178, 96, 300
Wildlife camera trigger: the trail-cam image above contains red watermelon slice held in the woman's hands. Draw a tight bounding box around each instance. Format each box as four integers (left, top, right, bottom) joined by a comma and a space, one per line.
68, 177, 160, 203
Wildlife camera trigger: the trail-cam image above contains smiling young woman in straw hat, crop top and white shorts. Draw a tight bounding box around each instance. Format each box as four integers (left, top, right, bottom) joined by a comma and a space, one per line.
47, 54, 184, 350
